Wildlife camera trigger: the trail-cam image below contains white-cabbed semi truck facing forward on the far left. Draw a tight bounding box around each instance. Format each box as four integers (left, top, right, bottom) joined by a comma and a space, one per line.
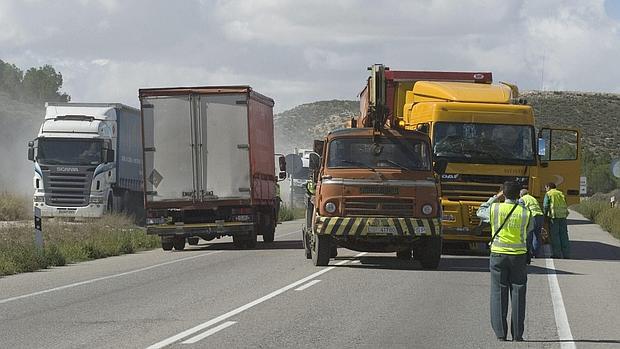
28, 103, 144, 218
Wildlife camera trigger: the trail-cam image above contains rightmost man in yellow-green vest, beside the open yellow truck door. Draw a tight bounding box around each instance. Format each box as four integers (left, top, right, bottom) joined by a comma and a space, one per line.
543, 183, 570, 258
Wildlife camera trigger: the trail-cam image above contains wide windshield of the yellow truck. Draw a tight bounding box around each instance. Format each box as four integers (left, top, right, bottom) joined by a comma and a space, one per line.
433, 122, 534, 165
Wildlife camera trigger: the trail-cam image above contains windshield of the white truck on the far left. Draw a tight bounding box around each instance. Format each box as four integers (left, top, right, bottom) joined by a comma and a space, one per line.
37, 138, 103, 165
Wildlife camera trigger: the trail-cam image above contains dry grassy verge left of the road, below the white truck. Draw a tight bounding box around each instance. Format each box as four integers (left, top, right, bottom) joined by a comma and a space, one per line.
0, 215, 159, 276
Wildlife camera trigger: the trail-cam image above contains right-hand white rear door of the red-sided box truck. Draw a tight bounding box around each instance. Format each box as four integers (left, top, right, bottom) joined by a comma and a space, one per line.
198, 93, 251, 200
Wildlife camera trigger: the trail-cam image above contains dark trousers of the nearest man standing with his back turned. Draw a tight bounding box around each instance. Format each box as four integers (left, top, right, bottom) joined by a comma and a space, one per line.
489, 253, 527, 339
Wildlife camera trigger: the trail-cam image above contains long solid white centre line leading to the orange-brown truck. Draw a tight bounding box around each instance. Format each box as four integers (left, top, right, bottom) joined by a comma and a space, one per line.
147, 252, 366, 349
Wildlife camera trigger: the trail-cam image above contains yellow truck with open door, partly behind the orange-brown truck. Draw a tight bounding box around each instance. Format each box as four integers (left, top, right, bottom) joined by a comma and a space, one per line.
358, 64, 580, 248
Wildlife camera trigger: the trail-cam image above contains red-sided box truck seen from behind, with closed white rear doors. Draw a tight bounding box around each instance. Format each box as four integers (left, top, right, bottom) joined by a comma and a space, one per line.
139, 86, 286, 250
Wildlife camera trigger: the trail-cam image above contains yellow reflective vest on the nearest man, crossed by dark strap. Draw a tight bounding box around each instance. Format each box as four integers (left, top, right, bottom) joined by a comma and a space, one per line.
491, 203, 532, 255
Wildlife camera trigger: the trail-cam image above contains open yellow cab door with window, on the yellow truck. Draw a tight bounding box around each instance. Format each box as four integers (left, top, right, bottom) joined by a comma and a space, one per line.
534, 128, 581, 205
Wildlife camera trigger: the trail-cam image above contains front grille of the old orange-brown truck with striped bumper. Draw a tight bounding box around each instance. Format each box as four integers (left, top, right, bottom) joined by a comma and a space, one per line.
344, 197, 415, 217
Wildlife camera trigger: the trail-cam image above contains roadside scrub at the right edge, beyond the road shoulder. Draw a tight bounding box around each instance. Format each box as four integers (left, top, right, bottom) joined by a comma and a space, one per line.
571, 190, 620, 239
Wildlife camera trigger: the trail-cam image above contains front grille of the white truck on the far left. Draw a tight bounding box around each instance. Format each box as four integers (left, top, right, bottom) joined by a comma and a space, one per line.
43, 169, 94, 207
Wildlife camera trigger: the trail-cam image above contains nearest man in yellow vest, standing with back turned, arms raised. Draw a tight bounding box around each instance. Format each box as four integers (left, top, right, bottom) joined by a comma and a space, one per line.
477, 182, 534, 342
